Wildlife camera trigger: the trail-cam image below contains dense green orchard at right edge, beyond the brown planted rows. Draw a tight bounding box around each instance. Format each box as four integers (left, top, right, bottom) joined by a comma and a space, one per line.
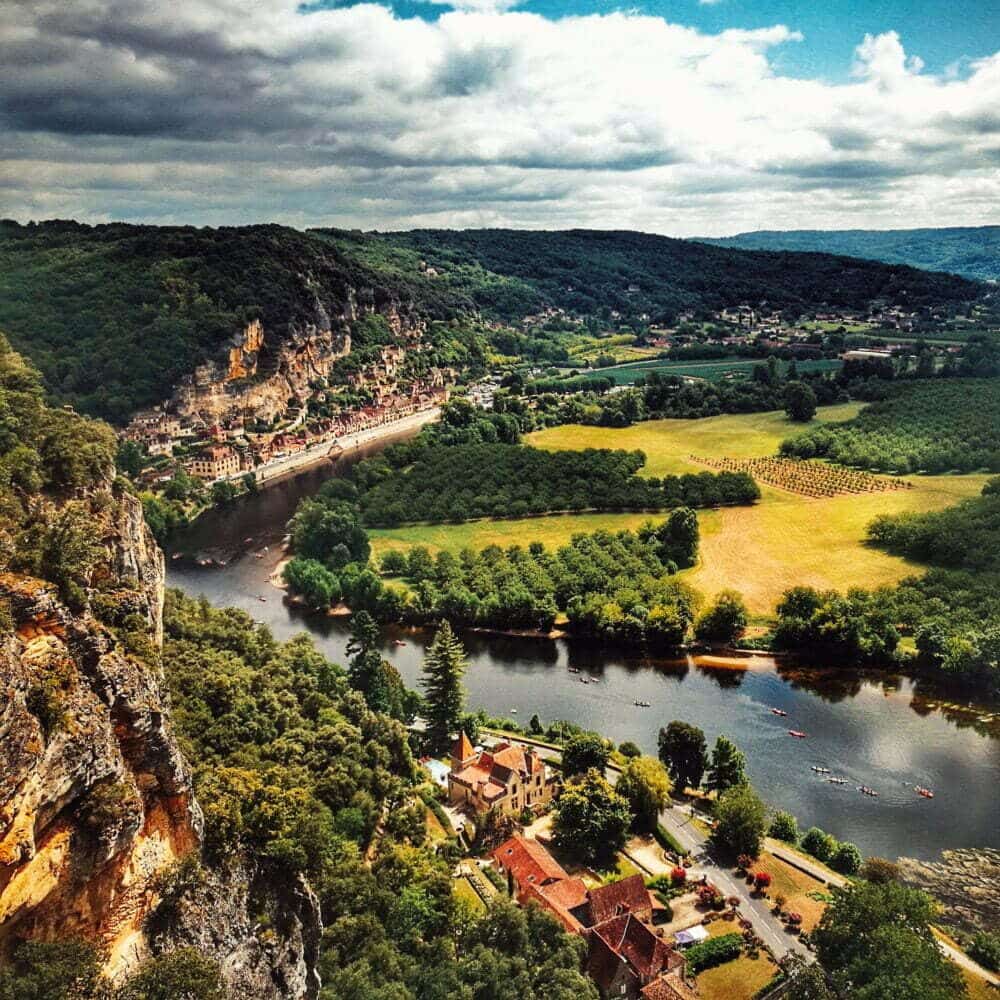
781, 380, 1000, 474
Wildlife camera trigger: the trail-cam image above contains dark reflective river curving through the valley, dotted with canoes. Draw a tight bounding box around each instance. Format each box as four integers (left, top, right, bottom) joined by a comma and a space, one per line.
167, 436, 1000, 859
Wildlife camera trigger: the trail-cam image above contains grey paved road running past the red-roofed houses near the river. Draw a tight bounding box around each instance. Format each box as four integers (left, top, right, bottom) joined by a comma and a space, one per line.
480, 734, 812, 960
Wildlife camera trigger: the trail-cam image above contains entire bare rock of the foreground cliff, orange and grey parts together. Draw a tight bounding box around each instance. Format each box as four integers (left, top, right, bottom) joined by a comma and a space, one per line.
0, 489, 322, 1000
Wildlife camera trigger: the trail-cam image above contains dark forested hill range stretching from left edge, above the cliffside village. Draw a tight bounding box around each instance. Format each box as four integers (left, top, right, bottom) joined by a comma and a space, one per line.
0, 221, 983, 421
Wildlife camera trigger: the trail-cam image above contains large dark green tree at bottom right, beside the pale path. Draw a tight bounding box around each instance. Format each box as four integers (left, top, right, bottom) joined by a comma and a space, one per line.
812, 882, 965, 1000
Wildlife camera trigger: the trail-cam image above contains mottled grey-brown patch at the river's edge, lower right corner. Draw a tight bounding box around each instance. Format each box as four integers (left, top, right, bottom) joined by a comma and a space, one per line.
899, 848, 1000, 932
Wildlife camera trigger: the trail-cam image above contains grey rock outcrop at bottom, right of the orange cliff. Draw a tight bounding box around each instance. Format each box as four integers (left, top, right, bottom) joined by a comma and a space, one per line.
148, 857, 323, 1000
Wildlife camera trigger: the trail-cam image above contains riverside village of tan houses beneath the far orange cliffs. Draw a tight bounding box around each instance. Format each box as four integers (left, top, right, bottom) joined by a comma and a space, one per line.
122, 324, 457, 491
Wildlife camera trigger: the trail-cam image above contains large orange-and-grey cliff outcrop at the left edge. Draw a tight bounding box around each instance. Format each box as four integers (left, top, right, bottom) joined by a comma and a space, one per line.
0, 576, 201, 974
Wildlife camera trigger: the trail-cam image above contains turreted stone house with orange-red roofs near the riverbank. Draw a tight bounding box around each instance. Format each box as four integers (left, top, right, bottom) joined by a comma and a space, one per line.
448, 732, 559, 817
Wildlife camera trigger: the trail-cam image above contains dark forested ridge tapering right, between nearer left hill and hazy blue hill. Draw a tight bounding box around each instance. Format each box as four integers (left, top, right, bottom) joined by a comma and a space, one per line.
381, 229, 979, 322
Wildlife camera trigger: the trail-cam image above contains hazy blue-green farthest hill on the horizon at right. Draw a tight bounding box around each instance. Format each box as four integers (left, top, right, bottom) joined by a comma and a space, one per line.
698, 226, 1000, 281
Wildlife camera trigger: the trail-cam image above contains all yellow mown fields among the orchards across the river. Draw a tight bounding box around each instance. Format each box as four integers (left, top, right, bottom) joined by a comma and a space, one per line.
371, 404, 989, 617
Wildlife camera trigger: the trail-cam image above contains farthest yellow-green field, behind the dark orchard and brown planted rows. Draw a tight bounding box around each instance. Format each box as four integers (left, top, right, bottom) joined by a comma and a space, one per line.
524, 403, 861, 476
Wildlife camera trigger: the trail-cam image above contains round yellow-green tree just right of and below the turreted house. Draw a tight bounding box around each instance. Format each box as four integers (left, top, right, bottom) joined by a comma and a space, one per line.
552, 771, 632, 862
